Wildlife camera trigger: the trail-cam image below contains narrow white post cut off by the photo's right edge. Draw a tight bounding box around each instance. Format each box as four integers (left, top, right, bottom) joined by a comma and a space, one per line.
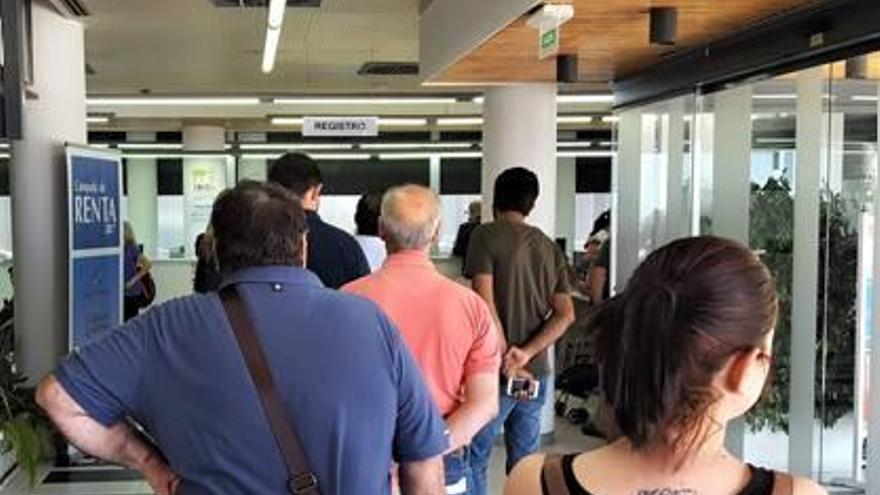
868, 76, 880, 493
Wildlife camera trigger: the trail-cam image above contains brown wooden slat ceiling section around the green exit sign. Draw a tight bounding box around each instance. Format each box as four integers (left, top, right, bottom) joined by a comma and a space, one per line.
437, 0, 816, 83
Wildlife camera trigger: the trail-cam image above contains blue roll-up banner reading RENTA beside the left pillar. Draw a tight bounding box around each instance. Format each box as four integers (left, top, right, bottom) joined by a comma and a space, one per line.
67, 146, 123, 349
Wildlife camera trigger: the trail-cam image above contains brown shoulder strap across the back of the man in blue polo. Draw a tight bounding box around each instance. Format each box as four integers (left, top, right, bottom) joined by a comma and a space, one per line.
220, 285, 321, 495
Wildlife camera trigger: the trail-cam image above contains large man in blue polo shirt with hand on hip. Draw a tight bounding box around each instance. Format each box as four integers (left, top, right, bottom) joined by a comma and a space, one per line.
37, 182, 449, 495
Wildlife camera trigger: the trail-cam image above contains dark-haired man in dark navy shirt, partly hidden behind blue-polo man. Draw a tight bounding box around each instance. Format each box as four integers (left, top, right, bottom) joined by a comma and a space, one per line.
269, 153, 370, 289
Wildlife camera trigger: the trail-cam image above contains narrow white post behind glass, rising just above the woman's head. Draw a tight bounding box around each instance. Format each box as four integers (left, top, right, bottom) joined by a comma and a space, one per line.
666, 98, 690, 242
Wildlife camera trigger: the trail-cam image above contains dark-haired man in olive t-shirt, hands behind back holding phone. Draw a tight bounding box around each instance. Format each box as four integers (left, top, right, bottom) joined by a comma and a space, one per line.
464, 168, 574, 495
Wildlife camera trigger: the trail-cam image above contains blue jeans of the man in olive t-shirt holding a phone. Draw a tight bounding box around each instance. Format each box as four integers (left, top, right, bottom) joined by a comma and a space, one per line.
471, 378, 547, 495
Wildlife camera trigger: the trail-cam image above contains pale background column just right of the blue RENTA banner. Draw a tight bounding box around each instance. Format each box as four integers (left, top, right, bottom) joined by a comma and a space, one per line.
126, 132, 159, 258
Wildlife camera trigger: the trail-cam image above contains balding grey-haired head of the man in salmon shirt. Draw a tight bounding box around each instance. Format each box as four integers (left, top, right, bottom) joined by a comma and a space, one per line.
380, 185, 440, 252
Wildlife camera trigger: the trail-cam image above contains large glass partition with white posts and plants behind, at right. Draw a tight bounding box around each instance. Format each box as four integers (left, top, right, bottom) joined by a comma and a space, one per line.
618, 50, 880, 492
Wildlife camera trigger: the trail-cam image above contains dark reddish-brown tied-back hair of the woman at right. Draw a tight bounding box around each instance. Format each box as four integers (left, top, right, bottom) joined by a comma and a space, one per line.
591, 237, 778, 454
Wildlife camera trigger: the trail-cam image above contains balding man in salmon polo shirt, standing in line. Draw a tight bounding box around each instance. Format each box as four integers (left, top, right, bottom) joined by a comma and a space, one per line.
342, 185, 501, 494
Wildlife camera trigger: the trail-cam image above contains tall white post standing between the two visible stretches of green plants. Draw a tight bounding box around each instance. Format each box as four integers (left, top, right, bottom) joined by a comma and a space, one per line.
789, 67, 826, 476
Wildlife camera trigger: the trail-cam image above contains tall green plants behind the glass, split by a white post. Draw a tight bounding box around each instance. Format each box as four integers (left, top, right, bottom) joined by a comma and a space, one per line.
747, 178, 858, 432
